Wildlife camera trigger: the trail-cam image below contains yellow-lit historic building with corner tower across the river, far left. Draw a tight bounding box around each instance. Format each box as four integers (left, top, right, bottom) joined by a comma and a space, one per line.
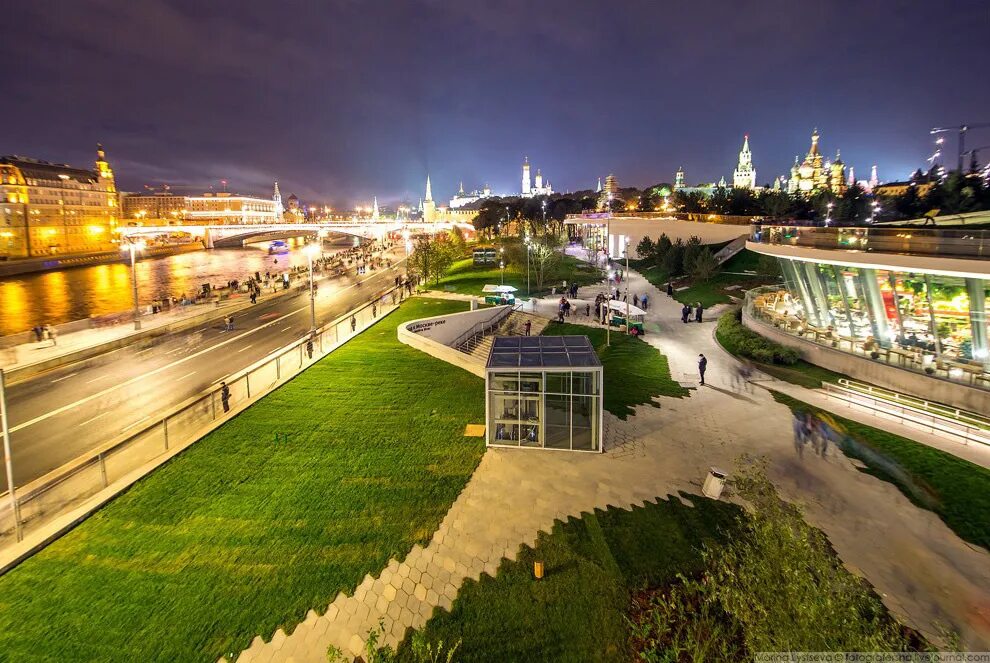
0, 145, 120, 259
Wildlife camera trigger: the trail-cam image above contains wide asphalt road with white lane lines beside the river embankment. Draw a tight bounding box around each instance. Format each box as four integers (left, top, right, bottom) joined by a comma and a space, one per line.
0, 249, 404, 492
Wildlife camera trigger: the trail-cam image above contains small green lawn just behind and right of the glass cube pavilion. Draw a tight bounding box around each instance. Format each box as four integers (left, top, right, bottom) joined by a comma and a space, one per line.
543, 322, 690, 419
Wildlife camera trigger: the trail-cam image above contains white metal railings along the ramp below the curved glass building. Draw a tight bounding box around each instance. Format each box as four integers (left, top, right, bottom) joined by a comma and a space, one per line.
822, 380, 990, 446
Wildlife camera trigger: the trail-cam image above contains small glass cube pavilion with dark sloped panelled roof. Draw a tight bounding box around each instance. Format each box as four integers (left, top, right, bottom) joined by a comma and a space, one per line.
485, 336, 602, 452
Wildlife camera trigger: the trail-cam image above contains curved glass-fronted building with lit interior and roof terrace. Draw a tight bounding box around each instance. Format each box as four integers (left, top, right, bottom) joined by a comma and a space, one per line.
747, 226, 990, 389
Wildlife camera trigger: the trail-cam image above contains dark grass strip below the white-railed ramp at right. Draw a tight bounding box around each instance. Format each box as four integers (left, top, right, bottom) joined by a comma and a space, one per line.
772, 391, 990, 549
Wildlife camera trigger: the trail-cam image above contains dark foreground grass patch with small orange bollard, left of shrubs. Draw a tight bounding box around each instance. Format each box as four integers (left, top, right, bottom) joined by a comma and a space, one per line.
399, 493, 739, 663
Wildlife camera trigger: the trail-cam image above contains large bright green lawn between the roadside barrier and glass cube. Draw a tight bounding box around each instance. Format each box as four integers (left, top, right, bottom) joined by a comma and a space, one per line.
0, 298, 484, 662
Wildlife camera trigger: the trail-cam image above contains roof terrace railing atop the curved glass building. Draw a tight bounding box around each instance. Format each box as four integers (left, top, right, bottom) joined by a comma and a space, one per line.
749, 225, 990, 258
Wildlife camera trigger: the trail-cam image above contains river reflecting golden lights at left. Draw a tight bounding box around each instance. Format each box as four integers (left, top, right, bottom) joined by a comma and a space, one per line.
0, 238, 362, 336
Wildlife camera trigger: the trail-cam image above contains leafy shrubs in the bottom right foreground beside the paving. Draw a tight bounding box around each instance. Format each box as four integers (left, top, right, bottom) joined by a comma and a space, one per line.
631, 462, 929, 661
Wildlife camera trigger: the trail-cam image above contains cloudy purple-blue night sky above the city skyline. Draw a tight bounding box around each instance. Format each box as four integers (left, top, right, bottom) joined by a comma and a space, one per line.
0, 0, 990, 206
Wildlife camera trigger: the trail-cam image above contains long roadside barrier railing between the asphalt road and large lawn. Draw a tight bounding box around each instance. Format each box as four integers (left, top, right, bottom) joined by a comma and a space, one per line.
0, 286, 404, 548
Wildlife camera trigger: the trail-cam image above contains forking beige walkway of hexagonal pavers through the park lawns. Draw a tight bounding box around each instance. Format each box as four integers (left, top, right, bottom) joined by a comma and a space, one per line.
237, 274, 990, 663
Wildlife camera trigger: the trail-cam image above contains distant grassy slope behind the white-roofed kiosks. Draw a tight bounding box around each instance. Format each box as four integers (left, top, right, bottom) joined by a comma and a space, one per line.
436, 253, 601, 297
